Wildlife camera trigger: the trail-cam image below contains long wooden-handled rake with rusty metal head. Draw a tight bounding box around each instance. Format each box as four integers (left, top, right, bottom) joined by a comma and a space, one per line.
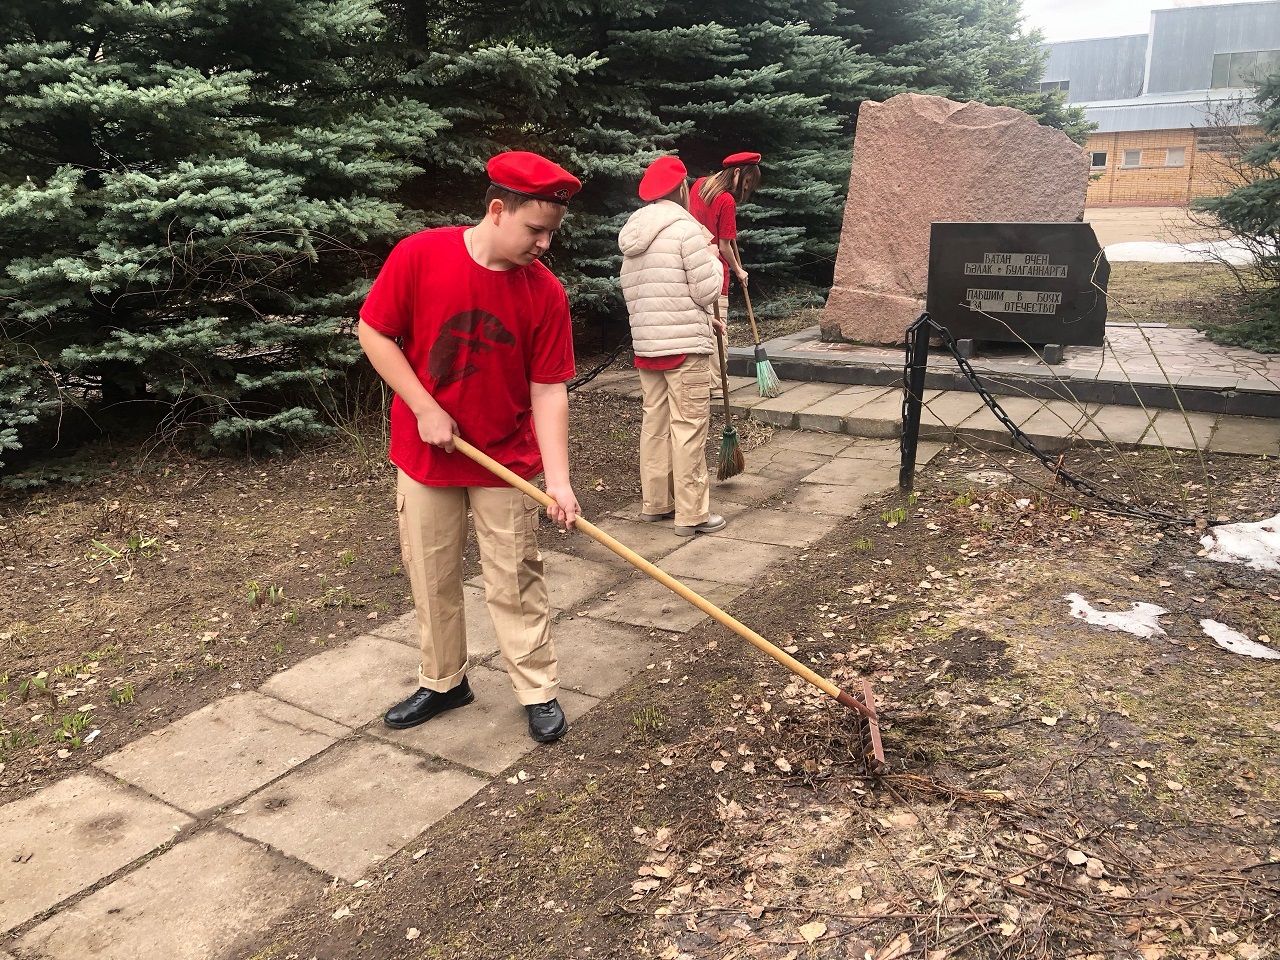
453, 436, 884, 773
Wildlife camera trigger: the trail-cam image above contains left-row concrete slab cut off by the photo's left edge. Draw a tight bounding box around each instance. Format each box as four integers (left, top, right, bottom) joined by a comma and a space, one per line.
0, 773, 191, 933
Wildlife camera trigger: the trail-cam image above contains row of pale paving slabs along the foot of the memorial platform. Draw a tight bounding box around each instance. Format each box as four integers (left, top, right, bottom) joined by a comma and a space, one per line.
589, 367, 1280, 457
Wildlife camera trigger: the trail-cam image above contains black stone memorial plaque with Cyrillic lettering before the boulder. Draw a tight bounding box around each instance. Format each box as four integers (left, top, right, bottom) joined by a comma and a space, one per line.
928, 223, 1111, 347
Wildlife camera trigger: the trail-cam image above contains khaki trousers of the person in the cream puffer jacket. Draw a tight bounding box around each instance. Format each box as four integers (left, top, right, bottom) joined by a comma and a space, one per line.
640, 353, 712, 526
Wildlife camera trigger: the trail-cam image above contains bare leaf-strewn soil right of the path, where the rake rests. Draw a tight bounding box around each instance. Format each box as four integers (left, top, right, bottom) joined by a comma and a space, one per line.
241, 449, 1280, 960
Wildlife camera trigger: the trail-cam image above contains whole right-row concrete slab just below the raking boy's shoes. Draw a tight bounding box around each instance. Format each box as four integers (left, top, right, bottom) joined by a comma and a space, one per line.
220, 739, 488, 881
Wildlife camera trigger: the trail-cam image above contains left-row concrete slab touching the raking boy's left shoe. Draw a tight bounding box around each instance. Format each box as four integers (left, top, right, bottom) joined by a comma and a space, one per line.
260, 636, 420, 727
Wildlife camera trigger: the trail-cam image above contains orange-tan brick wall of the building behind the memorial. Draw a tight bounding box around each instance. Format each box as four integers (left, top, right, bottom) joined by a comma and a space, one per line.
1084, 128, 1257, 206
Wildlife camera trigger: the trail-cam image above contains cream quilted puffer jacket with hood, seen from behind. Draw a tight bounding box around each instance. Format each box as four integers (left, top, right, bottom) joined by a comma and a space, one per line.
618, 200, 724, 357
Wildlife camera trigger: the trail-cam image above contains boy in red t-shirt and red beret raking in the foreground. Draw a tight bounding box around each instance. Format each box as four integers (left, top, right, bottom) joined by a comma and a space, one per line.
360, 151, 582, 742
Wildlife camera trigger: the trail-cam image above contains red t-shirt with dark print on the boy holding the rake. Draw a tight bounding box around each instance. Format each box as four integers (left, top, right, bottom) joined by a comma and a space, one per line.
360, 227, 573, 486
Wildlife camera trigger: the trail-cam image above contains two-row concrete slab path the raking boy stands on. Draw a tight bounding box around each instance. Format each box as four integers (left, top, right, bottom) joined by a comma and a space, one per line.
0, 431, 942, 960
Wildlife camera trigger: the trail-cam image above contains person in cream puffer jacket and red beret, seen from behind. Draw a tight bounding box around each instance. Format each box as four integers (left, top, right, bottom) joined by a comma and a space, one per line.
618, 156, 724, 536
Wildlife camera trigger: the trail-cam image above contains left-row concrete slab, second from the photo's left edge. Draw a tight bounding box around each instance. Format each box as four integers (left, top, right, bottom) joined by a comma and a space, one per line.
96, 691, 348, 813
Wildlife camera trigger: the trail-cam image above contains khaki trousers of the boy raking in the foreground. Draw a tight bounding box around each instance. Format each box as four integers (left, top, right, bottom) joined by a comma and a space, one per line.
396, 471, 559, 705
